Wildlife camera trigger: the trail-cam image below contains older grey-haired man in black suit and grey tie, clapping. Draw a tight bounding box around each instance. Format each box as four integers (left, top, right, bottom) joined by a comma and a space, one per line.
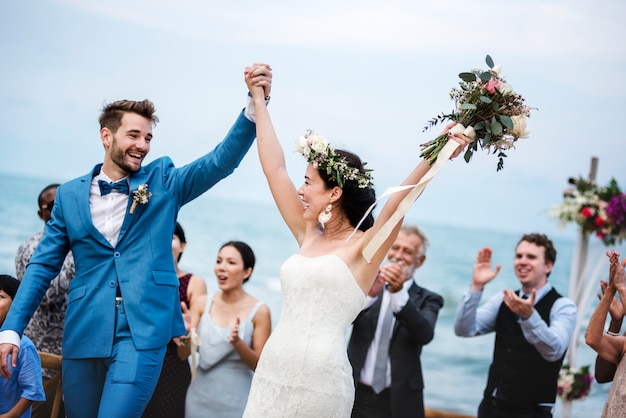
348, 225, 443, 418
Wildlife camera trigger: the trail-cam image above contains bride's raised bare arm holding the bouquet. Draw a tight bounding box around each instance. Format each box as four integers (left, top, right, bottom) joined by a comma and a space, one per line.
361, 128, 471, 266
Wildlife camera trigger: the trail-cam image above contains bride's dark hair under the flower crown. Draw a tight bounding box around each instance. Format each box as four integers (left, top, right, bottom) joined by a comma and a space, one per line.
318, 149, 376, 231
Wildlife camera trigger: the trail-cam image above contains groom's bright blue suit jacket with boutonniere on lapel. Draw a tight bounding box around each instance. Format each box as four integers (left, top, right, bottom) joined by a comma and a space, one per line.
2, 112, 255, 359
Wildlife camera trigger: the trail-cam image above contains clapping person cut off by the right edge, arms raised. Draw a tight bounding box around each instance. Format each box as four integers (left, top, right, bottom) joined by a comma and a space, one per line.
585, 251, 626, 418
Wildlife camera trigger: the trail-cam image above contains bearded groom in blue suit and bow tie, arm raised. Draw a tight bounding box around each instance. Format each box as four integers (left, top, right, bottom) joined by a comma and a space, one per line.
0, 64, 272, 418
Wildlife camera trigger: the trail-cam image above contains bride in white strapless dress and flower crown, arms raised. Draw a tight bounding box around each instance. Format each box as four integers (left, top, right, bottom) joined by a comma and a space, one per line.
243, 64, 469, 418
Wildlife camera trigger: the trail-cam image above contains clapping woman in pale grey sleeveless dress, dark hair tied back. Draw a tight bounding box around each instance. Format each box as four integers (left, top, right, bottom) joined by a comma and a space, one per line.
185, 241, 271, 418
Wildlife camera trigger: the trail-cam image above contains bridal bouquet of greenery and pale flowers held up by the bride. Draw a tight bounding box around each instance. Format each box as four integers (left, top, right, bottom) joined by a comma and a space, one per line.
420, 55, 531, 171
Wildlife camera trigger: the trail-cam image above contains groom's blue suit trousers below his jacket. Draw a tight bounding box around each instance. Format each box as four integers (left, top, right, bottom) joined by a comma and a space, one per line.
63, 301, 166, 418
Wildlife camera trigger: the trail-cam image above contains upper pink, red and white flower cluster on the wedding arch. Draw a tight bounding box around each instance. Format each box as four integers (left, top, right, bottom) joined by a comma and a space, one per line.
550, 178, 626, 246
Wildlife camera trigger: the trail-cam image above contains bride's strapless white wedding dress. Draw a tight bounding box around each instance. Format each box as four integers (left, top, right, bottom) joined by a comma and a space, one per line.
243, 254, 365, 418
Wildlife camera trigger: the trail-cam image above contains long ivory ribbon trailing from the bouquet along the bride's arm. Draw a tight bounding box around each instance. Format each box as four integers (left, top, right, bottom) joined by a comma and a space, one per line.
348, 139, 465, 263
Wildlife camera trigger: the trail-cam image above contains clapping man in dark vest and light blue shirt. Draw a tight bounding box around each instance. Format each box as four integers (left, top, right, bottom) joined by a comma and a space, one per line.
454, 234, 576, 418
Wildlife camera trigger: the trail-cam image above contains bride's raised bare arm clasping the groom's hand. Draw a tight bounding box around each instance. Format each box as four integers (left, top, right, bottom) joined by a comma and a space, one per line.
244, 64, 305, 244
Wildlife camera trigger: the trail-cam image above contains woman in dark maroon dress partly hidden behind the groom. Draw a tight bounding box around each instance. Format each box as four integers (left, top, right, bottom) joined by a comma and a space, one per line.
143, 222, 206, 418
